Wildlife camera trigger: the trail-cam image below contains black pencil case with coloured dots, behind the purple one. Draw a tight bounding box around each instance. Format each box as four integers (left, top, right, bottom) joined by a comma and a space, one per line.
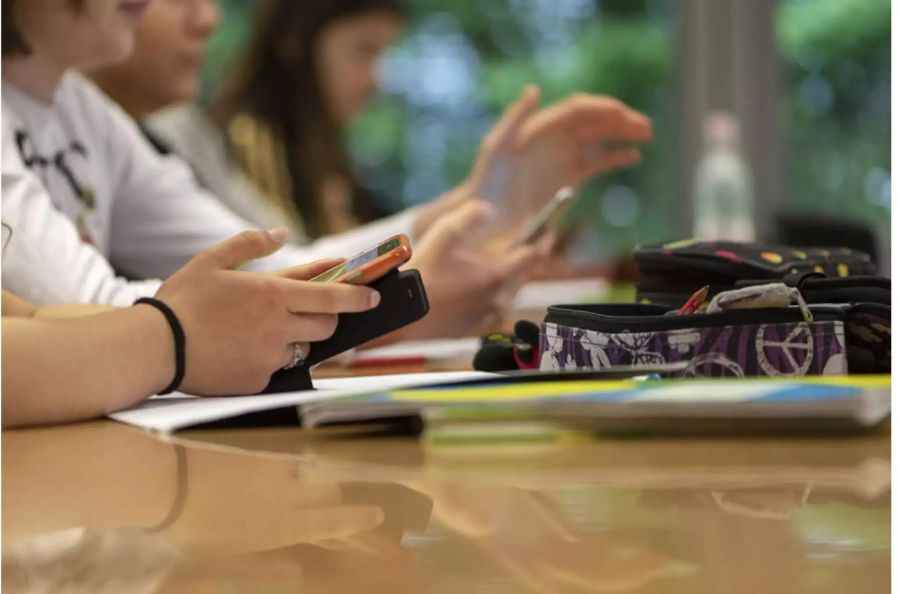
634, 239, 875, 307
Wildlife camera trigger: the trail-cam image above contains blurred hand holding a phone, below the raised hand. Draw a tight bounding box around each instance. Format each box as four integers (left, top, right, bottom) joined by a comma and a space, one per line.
392, 200, 546, 340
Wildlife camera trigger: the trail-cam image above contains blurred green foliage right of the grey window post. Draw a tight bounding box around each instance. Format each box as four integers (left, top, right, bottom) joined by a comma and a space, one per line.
777, 0, 891, 228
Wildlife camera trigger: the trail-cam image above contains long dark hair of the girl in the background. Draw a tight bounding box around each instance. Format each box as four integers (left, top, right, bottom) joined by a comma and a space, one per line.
209, 0, 404, 236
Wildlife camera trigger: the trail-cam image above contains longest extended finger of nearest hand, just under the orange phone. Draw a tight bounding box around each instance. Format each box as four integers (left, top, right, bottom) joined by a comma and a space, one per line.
277, 279, 381, 314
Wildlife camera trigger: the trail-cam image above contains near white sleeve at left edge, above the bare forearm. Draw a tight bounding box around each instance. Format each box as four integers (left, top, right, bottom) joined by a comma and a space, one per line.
0, 125, 160, 306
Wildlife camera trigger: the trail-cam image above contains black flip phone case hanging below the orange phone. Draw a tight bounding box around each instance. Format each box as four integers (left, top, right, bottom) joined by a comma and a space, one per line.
261, 270, 429, 394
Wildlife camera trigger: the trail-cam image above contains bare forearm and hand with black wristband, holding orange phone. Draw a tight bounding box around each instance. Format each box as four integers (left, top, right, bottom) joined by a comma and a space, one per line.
2, 223, 380, 427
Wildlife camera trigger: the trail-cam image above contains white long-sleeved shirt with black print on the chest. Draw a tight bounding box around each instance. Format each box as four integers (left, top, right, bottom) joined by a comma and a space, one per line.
0, 73, 415, 305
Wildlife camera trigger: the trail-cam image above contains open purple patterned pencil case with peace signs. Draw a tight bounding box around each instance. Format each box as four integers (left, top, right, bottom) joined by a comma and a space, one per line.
539, 303, 890, 377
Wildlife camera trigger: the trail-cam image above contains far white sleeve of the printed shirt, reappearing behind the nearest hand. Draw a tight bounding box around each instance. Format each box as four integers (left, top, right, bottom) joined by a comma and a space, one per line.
103, 91, 415, 278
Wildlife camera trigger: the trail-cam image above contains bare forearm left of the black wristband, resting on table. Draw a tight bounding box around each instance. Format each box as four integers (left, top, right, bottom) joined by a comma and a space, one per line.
3, 305, 174, 427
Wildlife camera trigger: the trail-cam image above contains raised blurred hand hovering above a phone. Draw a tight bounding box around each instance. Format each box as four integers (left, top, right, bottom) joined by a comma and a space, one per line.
464, 86, 652, 227
